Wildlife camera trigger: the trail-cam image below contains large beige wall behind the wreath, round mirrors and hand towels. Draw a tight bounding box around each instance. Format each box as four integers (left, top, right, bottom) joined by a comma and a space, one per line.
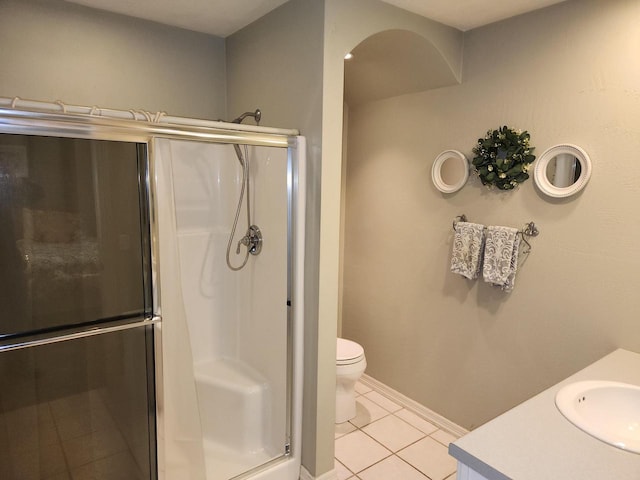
343, 0, 640, 429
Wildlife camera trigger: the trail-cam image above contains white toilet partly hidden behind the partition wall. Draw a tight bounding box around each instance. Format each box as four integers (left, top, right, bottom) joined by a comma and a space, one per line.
336, 338, 367, 423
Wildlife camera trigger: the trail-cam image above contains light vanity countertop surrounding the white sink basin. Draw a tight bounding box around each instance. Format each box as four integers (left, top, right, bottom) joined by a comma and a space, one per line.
449, 349, 640, 480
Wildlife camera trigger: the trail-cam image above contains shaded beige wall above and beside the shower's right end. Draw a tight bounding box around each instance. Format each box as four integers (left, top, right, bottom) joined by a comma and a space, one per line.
227, 0, 328, 475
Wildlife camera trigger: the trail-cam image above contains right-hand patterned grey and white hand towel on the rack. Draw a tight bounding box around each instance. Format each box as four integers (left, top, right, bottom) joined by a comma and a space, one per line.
482, 226, 520, 292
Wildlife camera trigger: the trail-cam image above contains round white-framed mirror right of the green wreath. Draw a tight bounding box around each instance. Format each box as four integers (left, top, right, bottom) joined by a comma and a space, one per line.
533, 144, 591, 198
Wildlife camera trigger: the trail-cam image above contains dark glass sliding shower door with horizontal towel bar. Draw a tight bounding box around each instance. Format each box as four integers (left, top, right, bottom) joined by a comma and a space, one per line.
0, 134, 157, 480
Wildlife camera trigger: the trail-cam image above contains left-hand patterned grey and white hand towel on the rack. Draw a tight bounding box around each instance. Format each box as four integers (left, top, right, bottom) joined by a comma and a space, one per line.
451, 222, 484, 280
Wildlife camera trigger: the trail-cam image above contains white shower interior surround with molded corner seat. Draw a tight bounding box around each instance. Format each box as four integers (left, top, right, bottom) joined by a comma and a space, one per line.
153, 138, 304, 480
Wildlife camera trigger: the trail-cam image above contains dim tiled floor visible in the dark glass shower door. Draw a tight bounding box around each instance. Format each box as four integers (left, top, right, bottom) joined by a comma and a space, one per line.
0, 390, 148, 480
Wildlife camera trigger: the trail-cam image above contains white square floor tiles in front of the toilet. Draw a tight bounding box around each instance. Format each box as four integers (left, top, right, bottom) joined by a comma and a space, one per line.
335, 382, 456, 480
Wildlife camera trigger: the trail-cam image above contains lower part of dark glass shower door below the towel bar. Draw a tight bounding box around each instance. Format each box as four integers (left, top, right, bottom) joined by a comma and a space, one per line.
0, 327, 156, 480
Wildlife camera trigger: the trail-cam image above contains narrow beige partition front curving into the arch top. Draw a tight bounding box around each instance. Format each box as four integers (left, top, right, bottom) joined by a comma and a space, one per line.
317, 0, 463, 473
